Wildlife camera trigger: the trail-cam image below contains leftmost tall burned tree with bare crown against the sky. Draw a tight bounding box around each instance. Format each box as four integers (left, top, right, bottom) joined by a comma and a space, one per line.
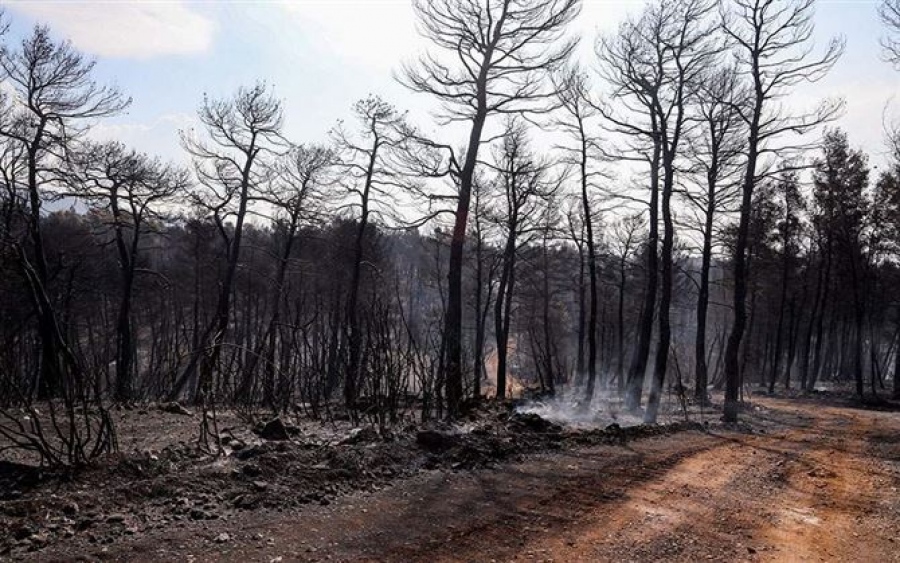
0, 27, 130, 398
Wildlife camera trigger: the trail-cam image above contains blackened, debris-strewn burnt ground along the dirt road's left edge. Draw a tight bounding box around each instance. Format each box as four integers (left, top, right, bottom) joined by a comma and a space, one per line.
0, 393, 701, 559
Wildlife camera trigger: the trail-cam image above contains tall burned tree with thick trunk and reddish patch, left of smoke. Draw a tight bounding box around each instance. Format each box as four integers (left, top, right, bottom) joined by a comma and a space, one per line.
402, 0, 580, 416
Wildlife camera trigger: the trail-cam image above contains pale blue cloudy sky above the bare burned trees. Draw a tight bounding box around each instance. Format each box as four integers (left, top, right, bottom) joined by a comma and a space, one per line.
2, 0, 900, 172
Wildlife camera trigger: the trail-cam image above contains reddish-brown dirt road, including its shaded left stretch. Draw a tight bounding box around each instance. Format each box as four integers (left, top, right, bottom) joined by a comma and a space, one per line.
35, 399, 900, 562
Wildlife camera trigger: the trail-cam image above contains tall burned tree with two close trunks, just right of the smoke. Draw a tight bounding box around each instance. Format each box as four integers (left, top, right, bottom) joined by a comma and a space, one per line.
596, 0, 717, 422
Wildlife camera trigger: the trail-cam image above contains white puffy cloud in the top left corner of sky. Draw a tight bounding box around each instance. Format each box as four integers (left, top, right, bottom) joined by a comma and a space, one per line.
9, 0, 215, 59
